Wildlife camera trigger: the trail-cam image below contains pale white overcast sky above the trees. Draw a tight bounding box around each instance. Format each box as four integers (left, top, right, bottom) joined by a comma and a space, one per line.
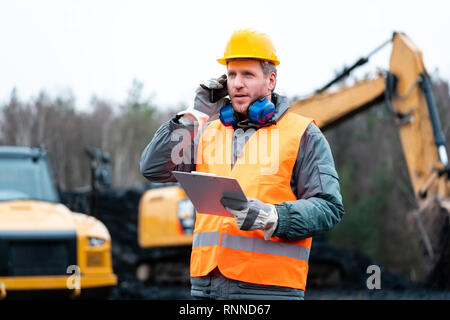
0, 0, 450, 110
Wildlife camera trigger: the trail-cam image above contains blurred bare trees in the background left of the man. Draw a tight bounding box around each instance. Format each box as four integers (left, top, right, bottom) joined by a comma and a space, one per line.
0, 80, 184, 190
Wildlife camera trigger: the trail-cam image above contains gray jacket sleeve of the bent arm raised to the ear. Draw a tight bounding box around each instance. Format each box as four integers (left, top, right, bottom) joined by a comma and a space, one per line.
140, 116, 195, 182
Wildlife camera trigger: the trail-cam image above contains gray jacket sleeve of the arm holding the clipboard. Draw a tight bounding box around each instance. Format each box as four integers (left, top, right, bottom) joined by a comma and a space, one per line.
273, 123, 345, 241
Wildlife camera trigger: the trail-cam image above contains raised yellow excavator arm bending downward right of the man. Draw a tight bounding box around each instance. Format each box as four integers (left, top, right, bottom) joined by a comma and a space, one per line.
291, 33, 450, 264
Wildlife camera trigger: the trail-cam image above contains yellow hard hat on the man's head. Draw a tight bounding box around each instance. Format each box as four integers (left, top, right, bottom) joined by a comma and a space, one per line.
217, 29, 280, 66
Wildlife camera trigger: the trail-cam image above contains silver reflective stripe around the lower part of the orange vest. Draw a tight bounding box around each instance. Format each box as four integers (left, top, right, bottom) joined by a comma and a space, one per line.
192, 231, 309, 262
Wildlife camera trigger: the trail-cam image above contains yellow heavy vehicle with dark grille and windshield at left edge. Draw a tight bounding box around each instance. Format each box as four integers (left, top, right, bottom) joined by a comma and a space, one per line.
0, 146, 117, 299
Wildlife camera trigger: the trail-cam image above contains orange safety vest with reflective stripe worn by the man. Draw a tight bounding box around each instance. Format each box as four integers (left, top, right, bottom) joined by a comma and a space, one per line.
191, 112, 313, 290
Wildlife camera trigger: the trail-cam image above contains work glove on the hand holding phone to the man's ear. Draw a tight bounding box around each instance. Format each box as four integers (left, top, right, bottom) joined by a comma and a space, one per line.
178, 74, 228, 126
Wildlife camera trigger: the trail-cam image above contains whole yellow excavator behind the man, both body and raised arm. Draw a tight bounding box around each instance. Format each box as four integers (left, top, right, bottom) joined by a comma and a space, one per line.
137, 32, 450, 280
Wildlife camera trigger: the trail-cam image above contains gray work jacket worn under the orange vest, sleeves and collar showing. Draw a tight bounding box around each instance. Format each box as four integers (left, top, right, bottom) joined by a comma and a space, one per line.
140, 94, 344, 299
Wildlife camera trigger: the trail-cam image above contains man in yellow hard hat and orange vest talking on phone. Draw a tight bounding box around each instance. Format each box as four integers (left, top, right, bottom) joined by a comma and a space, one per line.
140, 29, 344, 300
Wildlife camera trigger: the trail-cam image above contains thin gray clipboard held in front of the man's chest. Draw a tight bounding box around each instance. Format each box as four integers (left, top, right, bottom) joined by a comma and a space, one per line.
172, 171, 247, 217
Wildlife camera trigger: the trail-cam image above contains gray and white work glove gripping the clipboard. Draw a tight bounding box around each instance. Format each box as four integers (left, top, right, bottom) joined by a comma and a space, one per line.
220, 197, 278, 240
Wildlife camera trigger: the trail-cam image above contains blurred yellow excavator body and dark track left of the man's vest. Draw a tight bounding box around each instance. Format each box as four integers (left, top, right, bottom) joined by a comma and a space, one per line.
135, 185, 195, 282
